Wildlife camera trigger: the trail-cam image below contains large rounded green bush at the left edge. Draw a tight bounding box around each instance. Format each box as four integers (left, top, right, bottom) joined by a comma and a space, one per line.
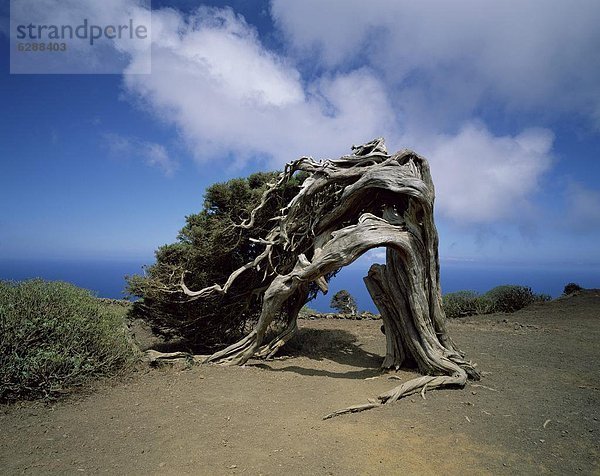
0, 279, 135, 402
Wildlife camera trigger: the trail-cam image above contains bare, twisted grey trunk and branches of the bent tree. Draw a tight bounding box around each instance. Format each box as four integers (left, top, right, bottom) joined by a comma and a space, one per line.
171, 139, 479, 417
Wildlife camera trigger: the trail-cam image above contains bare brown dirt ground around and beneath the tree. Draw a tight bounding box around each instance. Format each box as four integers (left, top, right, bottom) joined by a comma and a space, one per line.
0, 291, 600, 475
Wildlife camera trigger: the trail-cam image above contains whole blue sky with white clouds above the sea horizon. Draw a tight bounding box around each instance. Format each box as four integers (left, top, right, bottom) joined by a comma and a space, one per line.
0, 0, 600, 278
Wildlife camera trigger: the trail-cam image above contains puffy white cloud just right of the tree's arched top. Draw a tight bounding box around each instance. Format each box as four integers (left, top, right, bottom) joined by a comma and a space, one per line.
425, 123, 554, 224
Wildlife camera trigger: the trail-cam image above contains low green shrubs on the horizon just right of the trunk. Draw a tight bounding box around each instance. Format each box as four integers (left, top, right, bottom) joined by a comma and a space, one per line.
443, 285, 551, 319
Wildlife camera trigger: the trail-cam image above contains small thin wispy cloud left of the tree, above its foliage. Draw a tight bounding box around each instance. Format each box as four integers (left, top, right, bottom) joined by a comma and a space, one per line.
104, 133, 179, 177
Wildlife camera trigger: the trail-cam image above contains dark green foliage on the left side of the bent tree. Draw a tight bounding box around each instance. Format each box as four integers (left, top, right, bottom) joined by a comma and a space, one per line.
128, 172, 314, 352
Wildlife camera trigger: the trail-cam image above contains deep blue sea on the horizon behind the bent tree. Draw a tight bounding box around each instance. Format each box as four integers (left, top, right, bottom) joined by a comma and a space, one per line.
0, 259, 600, 312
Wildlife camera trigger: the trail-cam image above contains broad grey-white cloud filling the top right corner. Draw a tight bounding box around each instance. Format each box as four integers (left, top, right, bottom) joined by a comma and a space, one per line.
271, 0, 600, 128
